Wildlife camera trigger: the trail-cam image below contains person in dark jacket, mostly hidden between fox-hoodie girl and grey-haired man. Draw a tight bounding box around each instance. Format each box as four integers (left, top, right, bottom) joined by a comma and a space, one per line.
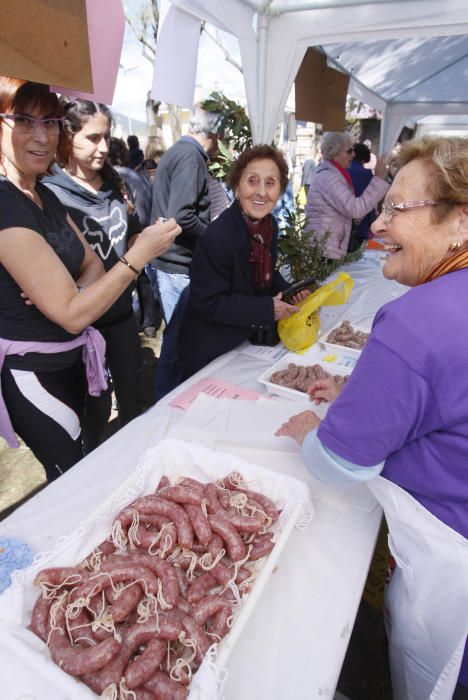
108, 136, 161, 338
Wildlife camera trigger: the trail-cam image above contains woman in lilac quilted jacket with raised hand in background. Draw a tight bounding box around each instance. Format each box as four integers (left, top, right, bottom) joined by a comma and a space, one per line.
305, 131, 389, 260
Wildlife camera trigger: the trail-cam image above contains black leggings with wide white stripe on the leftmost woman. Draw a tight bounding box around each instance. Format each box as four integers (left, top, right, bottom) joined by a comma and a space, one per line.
1, 359, 86, 481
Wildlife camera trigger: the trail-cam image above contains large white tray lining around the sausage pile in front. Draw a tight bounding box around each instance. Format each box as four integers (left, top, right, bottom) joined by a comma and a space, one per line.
0, 439, 310, 700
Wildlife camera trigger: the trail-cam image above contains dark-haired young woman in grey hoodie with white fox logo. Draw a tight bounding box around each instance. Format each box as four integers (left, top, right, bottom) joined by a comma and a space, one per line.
44, 99, 178, 452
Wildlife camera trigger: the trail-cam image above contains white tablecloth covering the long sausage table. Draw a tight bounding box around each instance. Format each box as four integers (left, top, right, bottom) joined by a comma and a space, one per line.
0, 253, 405, 700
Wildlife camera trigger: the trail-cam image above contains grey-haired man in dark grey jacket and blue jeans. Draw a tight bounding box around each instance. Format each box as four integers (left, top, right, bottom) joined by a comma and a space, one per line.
151, 105, 220, 397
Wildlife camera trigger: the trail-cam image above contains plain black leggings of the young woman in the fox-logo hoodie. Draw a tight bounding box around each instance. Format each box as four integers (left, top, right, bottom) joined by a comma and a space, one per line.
83, 315, 140, 454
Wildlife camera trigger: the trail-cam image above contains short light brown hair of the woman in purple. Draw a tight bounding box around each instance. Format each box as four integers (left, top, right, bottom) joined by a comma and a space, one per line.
397, 136, 468, 223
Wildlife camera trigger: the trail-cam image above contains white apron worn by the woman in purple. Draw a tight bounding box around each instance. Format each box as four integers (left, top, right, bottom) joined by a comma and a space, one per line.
367, 476, 468, 700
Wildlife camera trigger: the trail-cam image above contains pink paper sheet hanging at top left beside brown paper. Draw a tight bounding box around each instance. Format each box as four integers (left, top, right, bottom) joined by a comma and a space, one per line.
50, 0, 125, 105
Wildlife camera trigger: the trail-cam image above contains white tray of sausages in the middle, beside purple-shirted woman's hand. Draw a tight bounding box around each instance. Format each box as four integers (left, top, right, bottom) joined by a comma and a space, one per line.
257, 346, 356, 402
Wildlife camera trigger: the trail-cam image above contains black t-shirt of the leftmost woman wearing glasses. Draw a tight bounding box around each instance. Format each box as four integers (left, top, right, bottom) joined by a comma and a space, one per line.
0, 176, 84, 370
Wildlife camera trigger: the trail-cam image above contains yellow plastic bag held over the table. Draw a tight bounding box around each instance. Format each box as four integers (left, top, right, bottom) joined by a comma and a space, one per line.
278, 272, 354, 353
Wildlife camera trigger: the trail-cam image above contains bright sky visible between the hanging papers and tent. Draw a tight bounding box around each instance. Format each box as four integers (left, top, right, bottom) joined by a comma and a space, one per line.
112, 0, 245, 122
